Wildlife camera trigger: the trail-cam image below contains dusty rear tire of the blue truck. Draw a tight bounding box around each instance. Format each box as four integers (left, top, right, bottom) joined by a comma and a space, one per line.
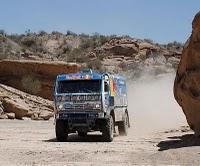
118, 112, 129, 136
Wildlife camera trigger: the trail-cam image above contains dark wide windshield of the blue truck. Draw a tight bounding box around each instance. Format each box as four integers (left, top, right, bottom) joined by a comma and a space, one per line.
57, 80, 101, 93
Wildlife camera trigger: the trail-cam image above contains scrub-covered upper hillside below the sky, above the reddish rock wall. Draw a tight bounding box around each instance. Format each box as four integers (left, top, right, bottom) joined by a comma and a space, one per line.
0, 31, 182, 73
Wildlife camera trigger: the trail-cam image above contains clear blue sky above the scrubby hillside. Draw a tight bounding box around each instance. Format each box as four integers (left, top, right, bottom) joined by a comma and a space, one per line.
0, 0, 200, 43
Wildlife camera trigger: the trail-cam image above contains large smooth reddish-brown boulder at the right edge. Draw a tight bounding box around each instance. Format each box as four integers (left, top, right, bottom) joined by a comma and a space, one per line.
174, 12, 200, 136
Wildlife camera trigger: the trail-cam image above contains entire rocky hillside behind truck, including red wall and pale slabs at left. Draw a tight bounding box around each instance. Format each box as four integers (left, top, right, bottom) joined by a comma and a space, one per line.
0, 31, 182, 120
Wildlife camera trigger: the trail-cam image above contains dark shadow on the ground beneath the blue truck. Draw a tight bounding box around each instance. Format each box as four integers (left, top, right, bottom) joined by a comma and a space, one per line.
43, 134, 113, 142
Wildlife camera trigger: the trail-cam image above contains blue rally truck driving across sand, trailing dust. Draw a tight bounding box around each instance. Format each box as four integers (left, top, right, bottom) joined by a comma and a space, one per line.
54, 69, 130, 142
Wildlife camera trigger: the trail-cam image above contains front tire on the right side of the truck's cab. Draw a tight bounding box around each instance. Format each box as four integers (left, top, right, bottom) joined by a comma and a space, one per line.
102, 116, 114, 142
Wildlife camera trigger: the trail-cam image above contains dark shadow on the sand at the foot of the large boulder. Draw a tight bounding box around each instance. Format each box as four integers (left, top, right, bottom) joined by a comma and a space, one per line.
157, 134, 200, 151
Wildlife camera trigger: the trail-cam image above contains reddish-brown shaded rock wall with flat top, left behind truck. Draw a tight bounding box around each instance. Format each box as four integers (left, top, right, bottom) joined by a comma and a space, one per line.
0, 60, 80, 100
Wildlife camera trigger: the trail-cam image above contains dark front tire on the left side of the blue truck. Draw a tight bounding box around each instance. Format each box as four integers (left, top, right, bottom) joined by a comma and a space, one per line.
55, 120, 68, 142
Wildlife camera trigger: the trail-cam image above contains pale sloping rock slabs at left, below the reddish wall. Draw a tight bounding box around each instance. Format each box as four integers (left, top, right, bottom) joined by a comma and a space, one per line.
0, 84, 53, 120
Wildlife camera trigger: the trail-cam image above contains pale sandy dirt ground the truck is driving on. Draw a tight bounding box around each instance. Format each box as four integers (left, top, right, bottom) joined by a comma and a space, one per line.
0, 120, 200, 165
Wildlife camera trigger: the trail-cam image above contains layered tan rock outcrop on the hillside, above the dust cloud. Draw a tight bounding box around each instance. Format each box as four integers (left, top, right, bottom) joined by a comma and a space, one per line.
92, 37, 182, 73
